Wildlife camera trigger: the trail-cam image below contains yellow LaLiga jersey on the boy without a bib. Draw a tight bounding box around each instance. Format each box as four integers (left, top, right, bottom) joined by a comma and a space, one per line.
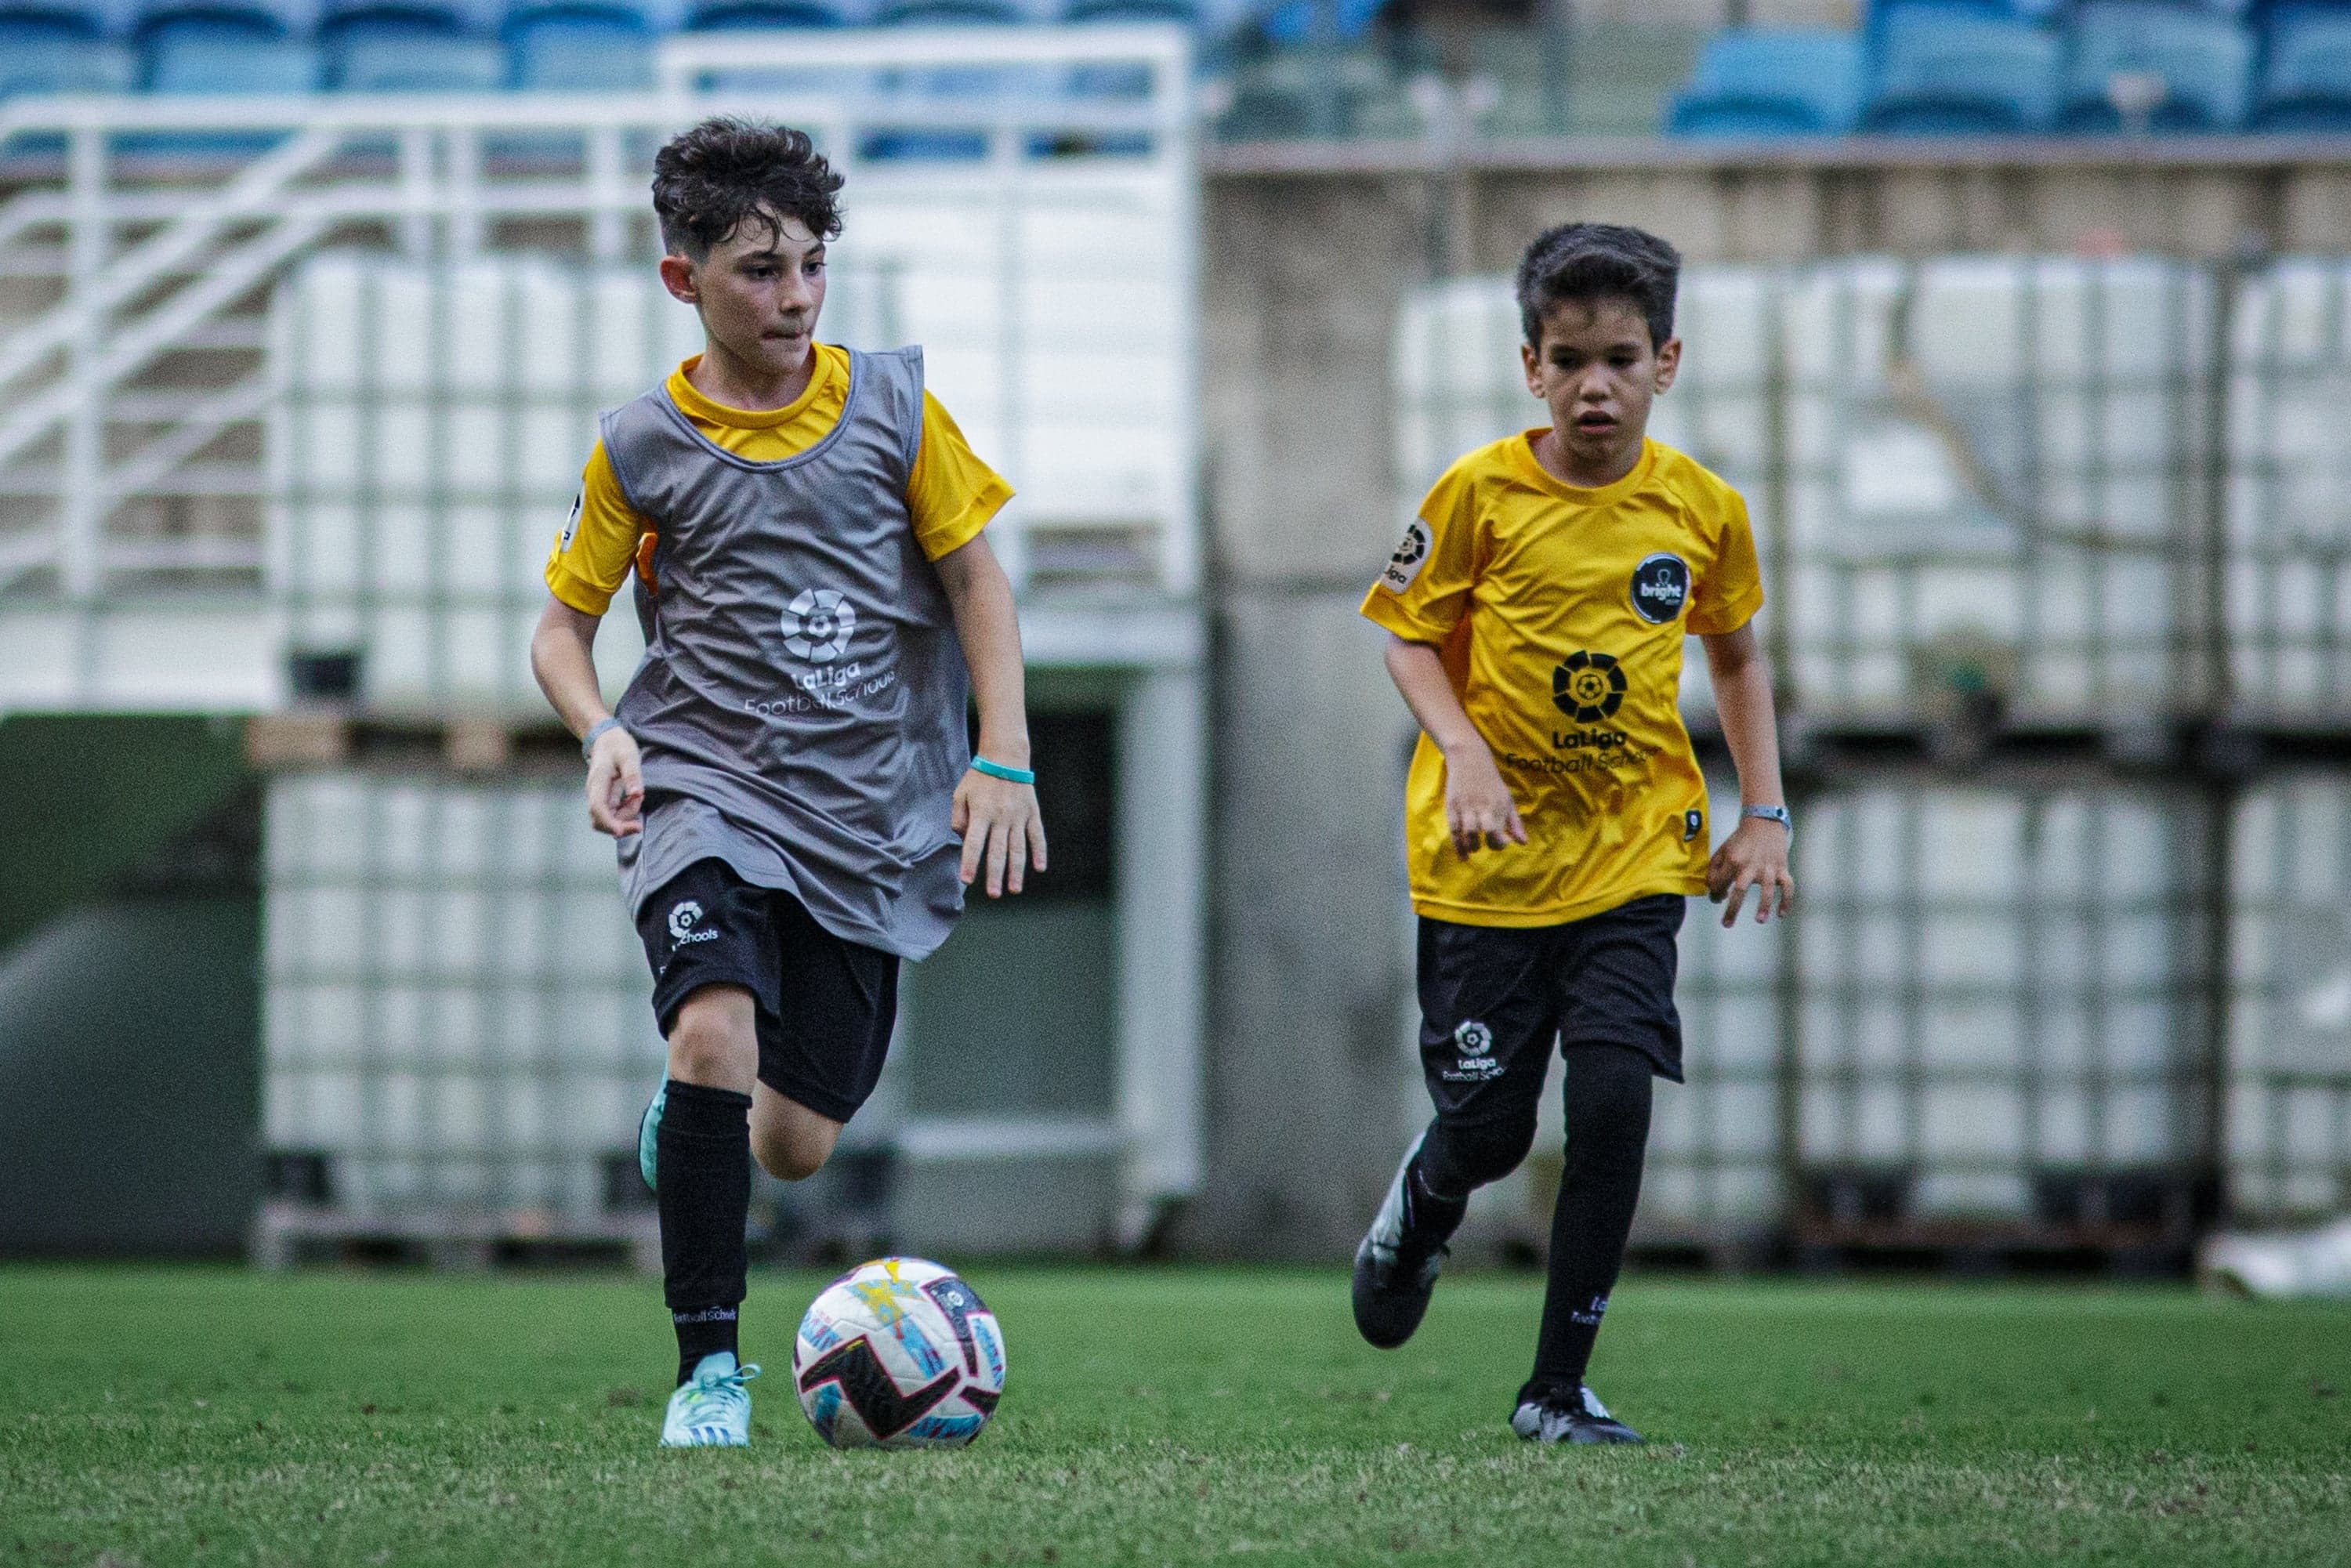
1364, 430, 1763, 926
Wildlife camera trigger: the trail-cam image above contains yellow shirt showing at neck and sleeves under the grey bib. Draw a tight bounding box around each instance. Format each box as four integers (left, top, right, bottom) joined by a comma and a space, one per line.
545, 343, 1013, 616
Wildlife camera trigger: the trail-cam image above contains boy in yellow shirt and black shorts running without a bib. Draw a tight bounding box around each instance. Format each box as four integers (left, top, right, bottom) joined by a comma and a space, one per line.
1354, 223, 1796, 1443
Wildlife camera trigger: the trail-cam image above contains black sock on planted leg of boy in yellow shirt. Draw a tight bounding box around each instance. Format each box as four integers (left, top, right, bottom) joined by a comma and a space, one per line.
1519, 1044, 1650, 1399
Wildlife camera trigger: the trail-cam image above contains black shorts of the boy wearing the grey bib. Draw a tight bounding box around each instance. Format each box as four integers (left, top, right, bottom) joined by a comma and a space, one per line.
637, 860, 898, 1121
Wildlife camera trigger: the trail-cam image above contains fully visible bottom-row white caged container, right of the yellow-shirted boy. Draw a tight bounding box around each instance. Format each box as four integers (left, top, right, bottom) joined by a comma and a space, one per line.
1794, 783, 2205, 1218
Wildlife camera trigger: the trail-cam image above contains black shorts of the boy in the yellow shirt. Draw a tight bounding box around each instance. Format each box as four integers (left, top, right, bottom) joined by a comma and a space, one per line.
1420, 893, 1686, 1121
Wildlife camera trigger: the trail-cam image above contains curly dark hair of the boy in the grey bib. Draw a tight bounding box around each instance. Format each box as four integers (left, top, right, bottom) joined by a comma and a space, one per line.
654, 115, 842, 261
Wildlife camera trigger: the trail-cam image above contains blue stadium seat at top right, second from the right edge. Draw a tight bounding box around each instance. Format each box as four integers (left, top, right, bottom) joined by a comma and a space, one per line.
2057, 0, 2252, 132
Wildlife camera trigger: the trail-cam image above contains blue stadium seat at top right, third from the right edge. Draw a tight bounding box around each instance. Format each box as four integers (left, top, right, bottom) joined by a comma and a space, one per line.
1862, 5, 2059, 136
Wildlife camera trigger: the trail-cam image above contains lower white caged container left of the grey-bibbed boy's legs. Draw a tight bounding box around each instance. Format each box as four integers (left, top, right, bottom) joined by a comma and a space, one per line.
263, 771, 663, 1222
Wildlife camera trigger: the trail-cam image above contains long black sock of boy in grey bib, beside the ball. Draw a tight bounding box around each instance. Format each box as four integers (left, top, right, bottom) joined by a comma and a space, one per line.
654, 1079, 750, 1382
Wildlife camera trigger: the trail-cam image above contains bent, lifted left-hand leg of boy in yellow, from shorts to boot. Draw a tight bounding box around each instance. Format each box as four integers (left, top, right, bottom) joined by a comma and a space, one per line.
1354, 919, 1559, 1349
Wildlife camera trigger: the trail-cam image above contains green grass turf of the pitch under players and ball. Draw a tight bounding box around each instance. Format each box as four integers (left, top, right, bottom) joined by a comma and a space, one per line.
0, 1267, 2351, 1568
